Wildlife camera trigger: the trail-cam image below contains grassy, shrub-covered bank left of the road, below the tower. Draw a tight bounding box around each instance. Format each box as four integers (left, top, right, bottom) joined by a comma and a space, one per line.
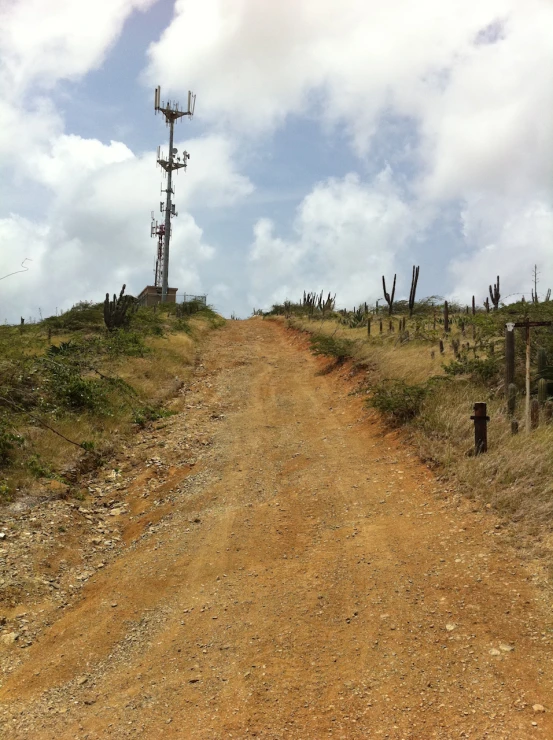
0, 303, 224, 503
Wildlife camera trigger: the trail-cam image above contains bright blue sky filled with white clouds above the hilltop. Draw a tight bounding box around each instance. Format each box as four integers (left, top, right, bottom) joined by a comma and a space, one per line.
0, 0, 553, 321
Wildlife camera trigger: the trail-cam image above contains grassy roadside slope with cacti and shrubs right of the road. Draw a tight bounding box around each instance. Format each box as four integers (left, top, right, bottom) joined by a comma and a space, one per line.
272, 303, 553, 549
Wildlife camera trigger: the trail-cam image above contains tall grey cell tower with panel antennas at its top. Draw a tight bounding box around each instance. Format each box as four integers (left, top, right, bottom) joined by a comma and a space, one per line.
151, 85, 196, 303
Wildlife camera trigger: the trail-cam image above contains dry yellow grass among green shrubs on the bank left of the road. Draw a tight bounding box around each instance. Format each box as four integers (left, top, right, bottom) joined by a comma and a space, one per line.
0, 317, 217, 500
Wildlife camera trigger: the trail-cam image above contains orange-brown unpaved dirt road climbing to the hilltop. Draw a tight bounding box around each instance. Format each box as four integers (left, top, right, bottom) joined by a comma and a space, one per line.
0, 319, 553, 740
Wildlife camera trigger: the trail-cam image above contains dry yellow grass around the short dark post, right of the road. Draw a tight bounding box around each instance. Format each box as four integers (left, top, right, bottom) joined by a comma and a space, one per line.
290, 318, 553, 559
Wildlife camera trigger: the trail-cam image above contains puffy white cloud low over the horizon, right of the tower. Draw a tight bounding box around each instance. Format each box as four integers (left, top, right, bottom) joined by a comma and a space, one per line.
249, 169, 418, 307
